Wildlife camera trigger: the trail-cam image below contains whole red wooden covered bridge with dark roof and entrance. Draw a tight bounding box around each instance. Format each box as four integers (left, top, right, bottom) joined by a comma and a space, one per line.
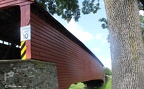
0, 0, 104, 89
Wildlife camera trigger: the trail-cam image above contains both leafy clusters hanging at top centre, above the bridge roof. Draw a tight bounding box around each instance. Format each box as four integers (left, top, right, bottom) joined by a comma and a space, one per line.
36, 0, 100, 21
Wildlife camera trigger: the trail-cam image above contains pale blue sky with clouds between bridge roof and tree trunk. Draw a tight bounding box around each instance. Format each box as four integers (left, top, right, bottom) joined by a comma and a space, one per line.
54, 0, 111, 69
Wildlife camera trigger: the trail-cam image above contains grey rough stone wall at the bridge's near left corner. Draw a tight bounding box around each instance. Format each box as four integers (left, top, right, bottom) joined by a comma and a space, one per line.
0, 60, 58, 89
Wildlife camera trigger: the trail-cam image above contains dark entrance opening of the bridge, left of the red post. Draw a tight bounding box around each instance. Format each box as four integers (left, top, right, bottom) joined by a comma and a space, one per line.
0, 6, 21, 60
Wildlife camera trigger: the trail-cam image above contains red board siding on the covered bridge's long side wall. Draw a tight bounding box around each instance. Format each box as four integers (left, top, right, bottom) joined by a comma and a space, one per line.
31, 13, 103, 89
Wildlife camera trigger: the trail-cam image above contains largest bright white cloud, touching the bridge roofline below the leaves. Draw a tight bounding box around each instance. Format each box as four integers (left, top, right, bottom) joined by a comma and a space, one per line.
65, 19, 93, 42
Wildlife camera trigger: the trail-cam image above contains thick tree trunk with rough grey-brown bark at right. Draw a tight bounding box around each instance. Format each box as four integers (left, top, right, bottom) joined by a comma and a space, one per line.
105, 0, 144, 89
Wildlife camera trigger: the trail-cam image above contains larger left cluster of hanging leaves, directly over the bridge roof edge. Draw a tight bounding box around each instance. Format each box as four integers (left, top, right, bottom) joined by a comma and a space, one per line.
36, 0, 80, 21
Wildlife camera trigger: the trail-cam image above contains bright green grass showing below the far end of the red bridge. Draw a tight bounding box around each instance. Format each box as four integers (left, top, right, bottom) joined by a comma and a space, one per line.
69, 78, 112, 89
